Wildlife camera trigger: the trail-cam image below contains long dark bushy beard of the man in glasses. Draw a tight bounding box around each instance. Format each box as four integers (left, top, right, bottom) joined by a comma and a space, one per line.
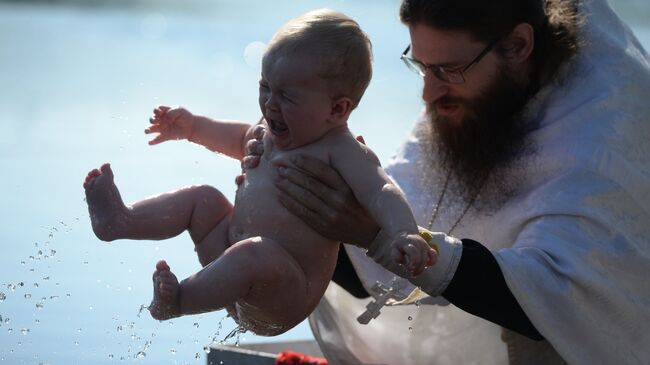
427, 66, 533, 203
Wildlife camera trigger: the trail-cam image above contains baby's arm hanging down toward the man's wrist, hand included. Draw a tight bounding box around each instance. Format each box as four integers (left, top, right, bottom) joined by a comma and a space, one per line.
331, 138, 436, 275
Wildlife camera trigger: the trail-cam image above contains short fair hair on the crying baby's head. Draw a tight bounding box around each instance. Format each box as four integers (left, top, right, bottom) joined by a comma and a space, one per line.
264, 9, 372, 108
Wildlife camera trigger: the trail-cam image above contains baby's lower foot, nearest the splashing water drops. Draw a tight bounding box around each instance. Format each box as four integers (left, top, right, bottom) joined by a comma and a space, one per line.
149, 260, 180, 321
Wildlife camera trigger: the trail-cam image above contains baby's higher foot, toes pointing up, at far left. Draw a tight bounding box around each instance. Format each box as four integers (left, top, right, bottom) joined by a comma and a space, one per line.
84, 164, 128, 241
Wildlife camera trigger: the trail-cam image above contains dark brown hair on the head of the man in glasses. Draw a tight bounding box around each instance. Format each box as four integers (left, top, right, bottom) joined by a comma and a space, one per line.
400, 0, 580, 86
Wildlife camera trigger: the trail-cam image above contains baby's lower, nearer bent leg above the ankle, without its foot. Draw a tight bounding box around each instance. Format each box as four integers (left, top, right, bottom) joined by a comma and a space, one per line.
173, 237, 313, 327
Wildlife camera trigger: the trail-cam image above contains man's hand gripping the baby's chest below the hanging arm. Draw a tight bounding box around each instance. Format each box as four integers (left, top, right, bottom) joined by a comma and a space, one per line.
275, 149, 379, 247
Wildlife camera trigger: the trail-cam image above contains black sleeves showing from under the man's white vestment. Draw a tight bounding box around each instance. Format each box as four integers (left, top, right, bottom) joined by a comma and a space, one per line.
332, 239, 544, 341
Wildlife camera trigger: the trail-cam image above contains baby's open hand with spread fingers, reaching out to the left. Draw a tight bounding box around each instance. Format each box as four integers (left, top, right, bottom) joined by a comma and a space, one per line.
144, 105, 194, 145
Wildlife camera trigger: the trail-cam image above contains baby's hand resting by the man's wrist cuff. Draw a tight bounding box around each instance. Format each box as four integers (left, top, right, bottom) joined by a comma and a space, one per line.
391, 233, 437, 276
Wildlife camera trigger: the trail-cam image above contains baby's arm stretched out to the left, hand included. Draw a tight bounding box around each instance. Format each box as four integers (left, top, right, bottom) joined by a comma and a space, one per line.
145, 105, 255, 160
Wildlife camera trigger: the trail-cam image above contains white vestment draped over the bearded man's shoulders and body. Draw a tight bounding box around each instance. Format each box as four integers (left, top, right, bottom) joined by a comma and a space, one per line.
310, 0, 650, 365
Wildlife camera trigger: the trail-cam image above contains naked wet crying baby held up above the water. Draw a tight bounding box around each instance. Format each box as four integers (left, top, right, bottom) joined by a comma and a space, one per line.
84, 10, 435, 336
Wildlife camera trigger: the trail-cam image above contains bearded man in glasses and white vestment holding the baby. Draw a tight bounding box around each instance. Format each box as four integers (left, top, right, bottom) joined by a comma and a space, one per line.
244, 0, 650, 364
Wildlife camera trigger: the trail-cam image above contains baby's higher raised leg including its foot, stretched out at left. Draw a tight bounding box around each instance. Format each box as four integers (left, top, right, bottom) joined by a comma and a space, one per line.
84, 164, 232, 262
